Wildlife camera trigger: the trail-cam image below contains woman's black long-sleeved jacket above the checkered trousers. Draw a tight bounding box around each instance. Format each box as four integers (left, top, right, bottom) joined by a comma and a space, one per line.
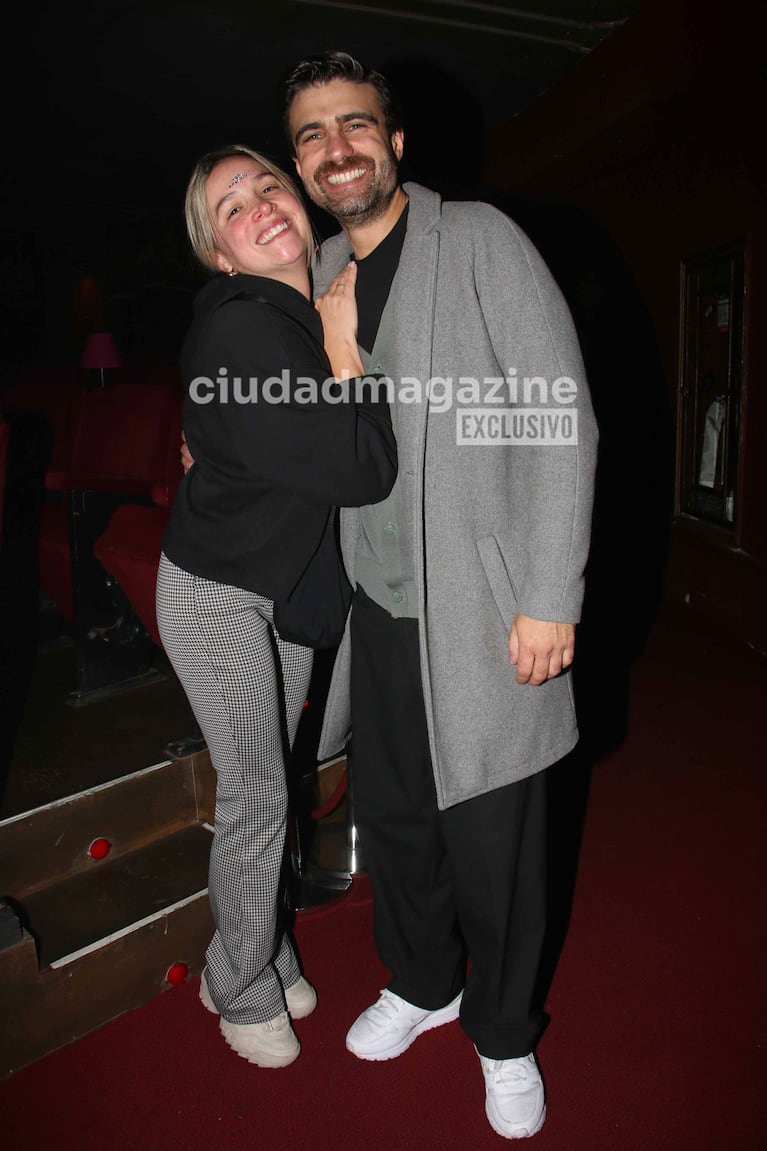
162, 275, 396, 600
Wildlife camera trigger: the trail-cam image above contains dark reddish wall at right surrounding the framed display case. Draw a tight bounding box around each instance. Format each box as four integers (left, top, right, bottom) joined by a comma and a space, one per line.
485, 0, 767, 651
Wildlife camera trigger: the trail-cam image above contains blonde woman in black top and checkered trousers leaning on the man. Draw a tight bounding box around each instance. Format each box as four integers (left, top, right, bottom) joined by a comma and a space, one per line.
157, 145, 396, 1067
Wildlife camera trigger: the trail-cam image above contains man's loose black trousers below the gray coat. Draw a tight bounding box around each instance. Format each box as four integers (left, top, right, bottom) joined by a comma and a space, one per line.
350, 589, 546, 1059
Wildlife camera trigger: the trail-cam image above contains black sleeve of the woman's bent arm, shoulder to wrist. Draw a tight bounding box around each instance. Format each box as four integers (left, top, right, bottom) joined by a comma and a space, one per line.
195, 300, 396, 506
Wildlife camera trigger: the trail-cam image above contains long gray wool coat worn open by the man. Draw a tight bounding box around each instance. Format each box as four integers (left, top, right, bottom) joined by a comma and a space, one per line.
314, 184, 597, 809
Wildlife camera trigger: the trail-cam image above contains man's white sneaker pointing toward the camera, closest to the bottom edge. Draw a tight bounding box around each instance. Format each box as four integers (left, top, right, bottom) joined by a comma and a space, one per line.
477, 1052, 546, 1139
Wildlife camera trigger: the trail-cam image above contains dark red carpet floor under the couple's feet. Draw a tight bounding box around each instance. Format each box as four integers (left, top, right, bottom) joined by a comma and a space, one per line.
0, 607, 767, 1151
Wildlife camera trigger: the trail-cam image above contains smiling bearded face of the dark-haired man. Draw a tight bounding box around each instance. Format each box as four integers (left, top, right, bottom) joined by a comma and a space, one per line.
289, 79, 403, 227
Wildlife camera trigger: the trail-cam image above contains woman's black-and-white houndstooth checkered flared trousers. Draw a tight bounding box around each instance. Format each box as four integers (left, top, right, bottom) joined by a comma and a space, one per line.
157, 555, 313, 1023
